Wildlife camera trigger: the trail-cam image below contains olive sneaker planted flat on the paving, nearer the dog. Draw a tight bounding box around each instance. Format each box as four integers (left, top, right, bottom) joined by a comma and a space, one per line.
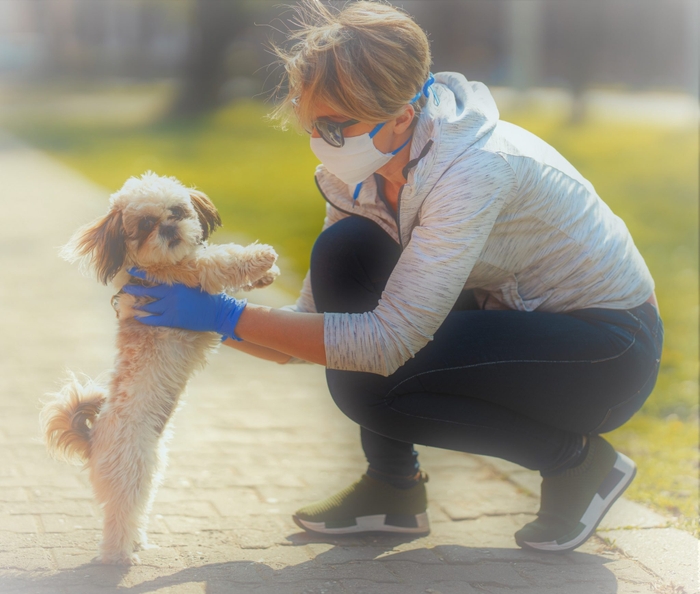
292, 472, 430, 534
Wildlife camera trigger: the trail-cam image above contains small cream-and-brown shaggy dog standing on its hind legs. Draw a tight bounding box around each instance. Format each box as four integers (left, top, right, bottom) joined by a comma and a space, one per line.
41, 172, 279, 564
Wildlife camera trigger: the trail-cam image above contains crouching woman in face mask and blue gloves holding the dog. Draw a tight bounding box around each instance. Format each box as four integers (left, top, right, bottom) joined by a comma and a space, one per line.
125, 1, 663, 551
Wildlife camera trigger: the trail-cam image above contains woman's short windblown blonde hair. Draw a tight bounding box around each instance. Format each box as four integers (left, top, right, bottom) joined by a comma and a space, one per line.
270, 0, 431, 130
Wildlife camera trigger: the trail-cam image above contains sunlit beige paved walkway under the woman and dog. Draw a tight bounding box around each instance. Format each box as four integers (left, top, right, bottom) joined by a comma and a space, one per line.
0, 138, 698, 594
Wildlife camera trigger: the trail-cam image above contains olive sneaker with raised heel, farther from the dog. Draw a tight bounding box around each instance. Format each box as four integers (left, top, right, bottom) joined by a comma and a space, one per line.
515, 435, 637, 552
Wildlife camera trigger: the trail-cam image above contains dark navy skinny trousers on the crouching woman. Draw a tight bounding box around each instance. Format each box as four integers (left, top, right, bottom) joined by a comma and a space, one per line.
311, 216, 663, 476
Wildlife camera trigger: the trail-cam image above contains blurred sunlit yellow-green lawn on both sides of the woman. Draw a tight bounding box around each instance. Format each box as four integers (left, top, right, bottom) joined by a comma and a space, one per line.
10, 91, 700, 534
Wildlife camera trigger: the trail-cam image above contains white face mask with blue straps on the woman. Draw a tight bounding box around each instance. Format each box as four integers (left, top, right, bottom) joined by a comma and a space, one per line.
311, 124, 410, 185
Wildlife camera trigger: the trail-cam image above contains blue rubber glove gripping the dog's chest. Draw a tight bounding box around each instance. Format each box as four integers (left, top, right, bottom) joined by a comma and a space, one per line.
122, 268, 248, 341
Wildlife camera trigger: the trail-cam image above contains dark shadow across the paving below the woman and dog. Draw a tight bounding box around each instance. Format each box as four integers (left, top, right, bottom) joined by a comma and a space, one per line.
0, 533, 618, 594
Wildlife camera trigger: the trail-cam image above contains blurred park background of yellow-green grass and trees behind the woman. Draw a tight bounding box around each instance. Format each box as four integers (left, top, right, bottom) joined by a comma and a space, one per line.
0, 0, 700, 534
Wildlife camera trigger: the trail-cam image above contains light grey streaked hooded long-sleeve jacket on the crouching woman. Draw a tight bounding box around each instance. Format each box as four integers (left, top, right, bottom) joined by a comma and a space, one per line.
294, 72, 654, 376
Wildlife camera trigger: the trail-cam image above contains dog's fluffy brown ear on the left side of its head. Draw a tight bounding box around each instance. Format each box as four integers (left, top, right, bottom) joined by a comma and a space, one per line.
61, 209, 126, 285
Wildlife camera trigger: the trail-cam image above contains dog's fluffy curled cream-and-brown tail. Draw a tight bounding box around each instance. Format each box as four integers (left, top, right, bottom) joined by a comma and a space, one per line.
41, 373, 106, 463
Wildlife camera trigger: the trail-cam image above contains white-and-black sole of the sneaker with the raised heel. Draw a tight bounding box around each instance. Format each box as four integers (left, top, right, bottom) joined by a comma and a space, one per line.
518, 452, 637, 553
